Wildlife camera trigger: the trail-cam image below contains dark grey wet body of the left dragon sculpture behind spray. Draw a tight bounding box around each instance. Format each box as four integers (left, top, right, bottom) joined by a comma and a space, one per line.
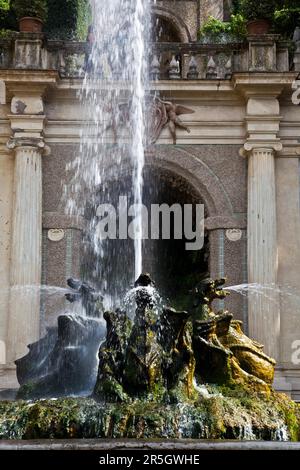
16, 314, 104, 399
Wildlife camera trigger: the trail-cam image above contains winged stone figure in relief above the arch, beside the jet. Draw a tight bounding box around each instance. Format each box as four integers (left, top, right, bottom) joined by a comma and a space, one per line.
150, 98, 195, 145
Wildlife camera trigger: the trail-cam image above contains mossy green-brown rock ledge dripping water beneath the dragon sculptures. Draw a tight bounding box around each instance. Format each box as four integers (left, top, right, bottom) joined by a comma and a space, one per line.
0, 386, 300, 441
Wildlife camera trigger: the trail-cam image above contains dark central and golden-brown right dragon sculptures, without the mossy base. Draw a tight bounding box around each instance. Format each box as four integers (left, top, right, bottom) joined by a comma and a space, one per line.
94, 274, 275, 402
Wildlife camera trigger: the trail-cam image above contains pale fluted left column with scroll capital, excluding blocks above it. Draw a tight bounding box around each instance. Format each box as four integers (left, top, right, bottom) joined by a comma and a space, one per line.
7, 139, 44, 363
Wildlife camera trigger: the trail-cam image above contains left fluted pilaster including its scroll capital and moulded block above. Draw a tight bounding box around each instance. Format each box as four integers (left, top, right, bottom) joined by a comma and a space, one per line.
2, 71, 56, 368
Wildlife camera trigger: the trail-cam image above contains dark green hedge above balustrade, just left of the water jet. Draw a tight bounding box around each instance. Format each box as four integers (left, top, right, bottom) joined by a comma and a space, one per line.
45, 0, 91, 40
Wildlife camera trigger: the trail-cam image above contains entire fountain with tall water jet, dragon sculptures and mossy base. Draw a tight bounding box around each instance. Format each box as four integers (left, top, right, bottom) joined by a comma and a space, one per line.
0, 0, 300, 440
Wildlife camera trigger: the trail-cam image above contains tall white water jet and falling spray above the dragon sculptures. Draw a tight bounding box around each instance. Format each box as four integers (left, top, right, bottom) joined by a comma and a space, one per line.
65, 0, 150, 303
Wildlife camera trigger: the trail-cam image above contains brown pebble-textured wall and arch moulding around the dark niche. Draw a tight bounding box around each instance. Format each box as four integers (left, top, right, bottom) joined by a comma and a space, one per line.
43, 143, 247, 324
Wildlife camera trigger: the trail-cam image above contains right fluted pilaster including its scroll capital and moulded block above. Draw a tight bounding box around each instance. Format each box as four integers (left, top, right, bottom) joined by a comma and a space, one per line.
241, 80, 282, 360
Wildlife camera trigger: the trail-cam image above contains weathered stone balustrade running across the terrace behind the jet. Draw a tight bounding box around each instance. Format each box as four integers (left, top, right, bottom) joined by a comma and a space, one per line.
0, 33, 300, 80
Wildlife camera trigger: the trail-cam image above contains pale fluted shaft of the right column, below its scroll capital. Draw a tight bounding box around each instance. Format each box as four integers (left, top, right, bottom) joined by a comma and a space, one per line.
246, 148, 280, 358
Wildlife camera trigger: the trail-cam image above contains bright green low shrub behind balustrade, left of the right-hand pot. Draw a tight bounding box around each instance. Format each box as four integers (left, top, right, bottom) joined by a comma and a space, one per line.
199, 13, 247, 41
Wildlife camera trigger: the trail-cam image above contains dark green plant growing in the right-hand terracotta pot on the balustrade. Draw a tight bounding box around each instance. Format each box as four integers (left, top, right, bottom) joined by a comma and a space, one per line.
239, 0, 281, 22
